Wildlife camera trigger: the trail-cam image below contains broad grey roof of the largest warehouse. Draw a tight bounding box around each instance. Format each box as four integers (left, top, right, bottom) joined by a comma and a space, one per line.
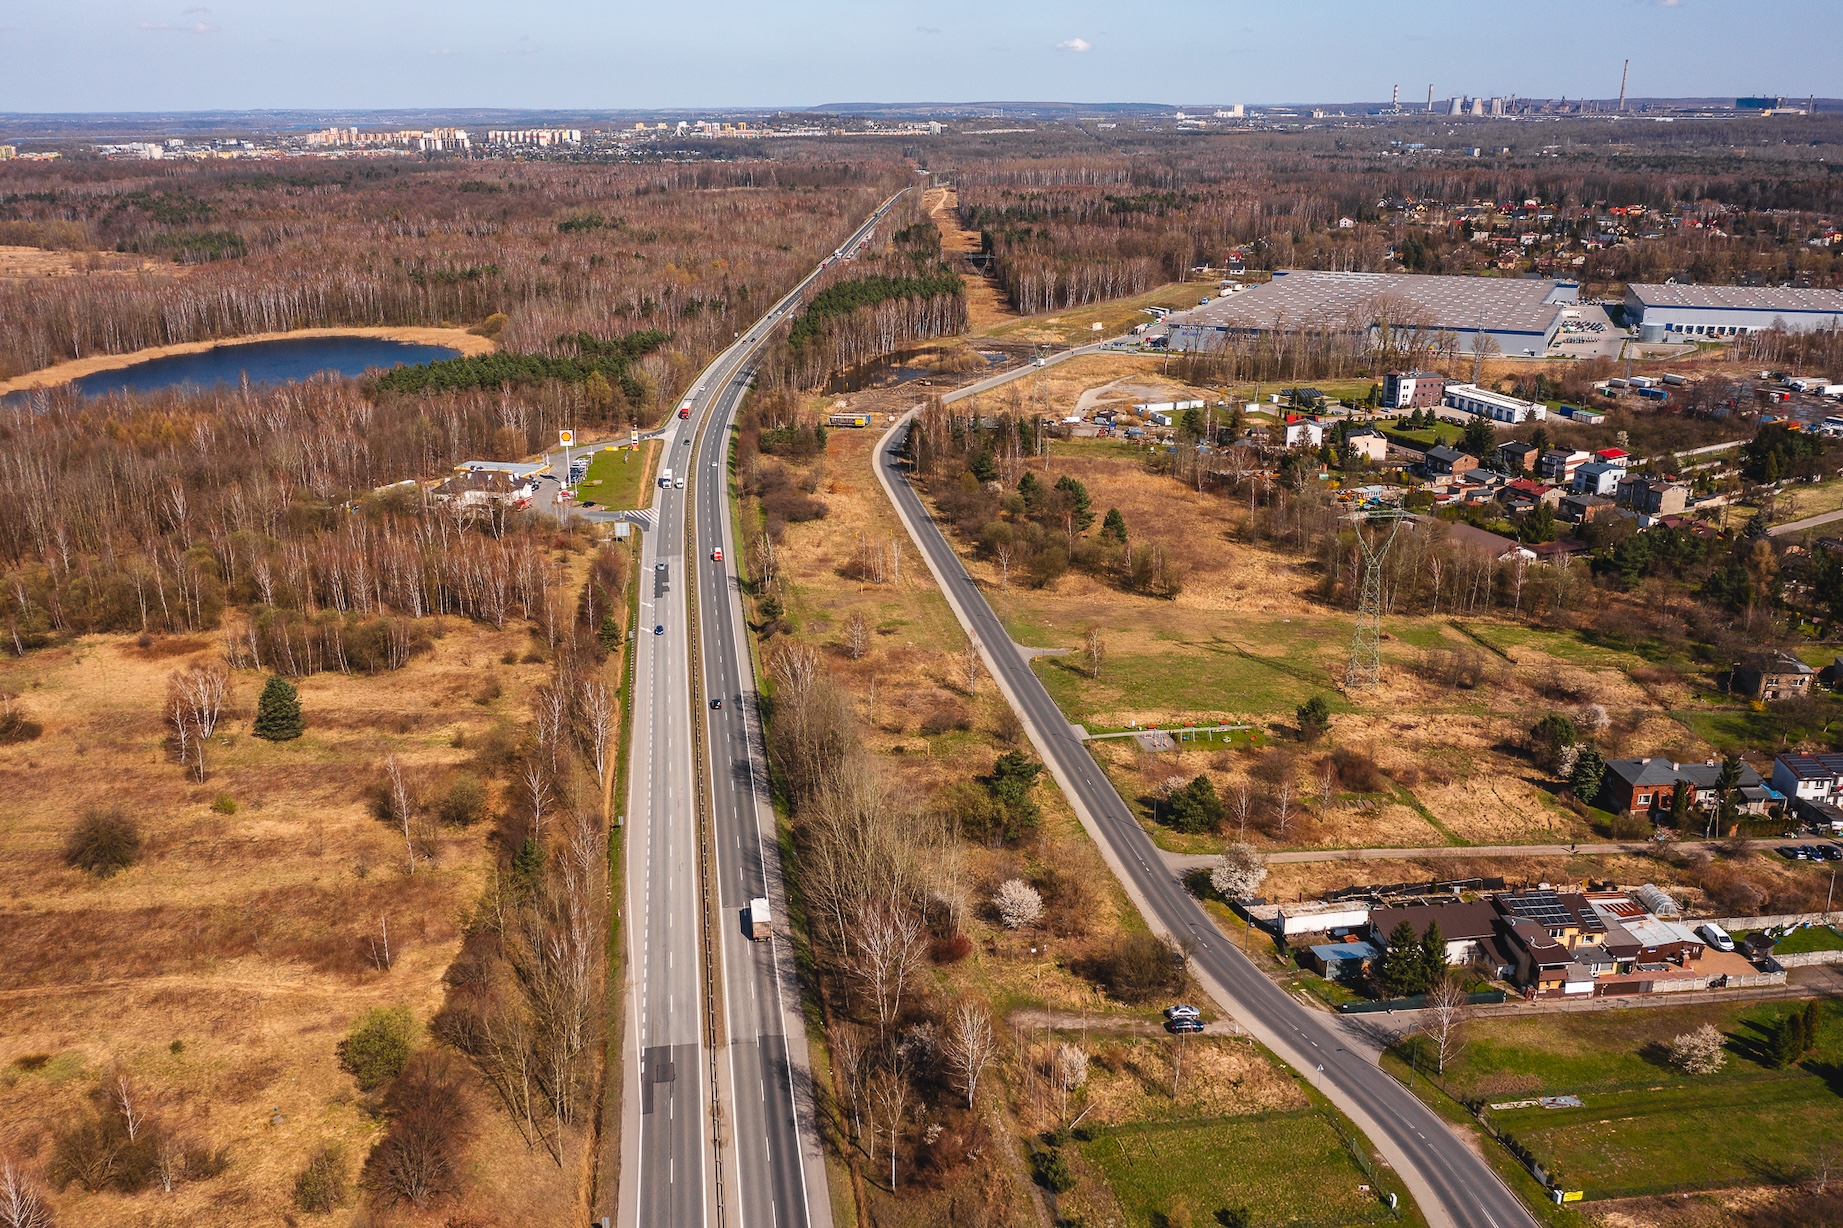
1170, 269, 1579, 332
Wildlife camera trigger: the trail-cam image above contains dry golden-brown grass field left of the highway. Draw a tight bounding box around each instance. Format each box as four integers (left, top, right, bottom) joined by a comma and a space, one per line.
0, 623, 579, 1226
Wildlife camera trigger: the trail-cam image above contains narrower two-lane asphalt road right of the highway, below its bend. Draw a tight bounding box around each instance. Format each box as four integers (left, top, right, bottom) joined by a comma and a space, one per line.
875, 420, 1535, 1228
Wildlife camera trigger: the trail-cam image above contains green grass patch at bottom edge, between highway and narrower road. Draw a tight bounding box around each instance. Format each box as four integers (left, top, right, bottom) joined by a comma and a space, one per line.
1082, 1110, 1393, 1228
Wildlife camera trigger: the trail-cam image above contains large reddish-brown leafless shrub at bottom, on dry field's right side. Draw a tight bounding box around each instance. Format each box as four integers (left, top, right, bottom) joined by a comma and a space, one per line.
365, 1051, 472, 1206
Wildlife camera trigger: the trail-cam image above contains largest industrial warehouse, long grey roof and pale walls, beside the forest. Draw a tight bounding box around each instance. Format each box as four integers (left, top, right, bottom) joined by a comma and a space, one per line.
1165, 269, 1581, 356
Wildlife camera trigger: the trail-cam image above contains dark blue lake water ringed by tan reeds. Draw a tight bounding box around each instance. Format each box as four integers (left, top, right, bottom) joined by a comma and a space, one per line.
6, 337, 461, 400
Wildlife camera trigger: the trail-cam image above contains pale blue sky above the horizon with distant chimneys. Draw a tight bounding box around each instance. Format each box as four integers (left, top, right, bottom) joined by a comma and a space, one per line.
0, 0, 1843, 112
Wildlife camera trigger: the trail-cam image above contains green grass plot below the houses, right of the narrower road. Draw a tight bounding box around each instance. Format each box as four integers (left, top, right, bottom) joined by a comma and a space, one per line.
1393, 1003, 1843, 1198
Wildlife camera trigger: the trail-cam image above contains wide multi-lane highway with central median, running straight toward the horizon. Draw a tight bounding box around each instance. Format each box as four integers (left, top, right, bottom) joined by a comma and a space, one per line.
617, 194, 901, 1228
